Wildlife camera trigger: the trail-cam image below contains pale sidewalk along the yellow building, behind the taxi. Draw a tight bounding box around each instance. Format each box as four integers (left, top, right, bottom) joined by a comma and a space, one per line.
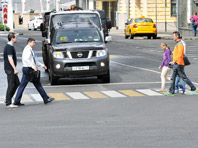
109, 29, 198, 40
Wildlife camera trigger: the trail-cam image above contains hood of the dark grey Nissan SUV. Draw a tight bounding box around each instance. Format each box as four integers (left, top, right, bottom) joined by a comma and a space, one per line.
52, 42, 105, 51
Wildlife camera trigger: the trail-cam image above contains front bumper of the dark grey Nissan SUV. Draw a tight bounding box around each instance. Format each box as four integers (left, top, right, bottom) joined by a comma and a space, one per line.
51, 55, 109, 78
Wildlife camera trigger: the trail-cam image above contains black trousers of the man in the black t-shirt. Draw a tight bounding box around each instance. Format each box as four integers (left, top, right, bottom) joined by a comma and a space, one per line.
5, 70, 20, 105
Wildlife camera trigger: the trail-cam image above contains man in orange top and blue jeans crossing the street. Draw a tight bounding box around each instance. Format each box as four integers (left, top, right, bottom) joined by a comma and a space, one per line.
164, 31, 198, 96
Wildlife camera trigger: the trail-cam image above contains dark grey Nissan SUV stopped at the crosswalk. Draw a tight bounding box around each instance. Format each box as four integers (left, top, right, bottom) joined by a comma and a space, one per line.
47, 22, 110, 85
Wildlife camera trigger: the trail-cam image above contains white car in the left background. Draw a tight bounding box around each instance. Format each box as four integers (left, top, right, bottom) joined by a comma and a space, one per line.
28, 16, 43, 30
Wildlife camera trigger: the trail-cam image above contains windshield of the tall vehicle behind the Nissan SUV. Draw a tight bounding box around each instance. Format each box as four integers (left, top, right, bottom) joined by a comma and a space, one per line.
50, 13, 101, 29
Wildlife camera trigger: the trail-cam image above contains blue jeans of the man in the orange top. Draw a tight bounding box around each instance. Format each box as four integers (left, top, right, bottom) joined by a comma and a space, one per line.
169, 63, 196, 94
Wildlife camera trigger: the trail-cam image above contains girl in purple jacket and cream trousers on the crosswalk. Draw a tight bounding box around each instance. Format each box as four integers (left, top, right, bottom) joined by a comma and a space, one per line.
159, 43, 171, 92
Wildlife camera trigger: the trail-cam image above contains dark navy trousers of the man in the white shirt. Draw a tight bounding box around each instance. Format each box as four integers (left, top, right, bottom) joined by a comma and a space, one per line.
14, 67, 49, 104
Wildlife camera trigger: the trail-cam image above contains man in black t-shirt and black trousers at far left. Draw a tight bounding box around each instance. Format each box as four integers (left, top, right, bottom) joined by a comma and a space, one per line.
3, 32, 20, 108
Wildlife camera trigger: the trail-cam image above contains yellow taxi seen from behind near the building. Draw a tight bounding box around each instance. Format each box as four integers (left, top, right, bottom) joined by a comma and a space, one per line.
124, 17, 157, 39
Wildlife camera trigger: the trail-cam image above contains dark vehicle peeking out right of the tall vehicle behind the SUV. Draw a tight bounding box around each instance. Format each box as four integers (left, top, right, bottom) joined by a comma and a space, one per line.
96, 10, 112, 39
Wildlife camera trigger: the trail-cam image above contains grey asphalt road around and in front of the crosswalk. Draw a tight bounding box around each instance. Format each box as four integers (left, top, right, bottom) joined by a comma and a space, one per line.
0, 29, 198, 148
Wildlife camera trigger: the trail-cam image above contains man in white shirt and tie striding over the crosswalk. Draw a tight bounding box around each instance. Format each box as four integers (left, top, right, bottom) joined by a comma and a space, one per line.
14, 38, 54, 106
